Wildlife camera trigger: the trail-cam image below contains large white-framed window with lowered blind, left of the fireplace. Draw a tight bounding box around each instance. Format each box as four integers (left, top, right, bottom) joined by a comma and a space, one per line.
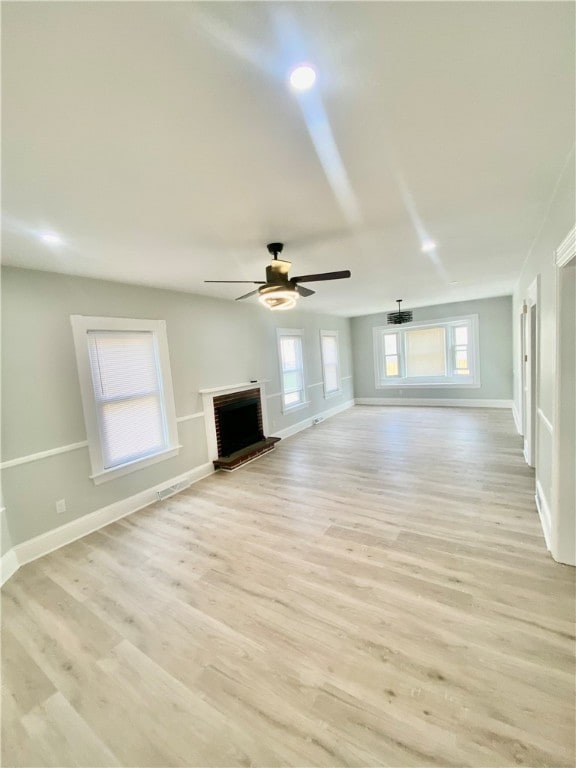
71, 315, 179, 483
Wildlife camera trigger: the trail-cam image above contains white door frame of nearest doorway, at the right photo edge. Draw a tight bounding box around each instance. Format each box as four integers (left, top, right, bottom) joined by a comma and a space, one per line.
551, 225, 576, 565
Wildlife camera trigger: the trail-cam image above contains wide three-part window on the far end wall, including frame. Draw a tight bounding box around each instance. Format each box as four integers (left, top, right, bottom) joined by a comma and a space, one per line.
374, 315, 480, 388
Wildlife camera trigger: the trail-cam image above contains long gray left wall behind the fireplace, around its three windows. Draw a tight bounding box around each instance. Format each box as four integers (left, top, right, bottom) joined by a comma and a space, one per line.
2, 268, 353, 545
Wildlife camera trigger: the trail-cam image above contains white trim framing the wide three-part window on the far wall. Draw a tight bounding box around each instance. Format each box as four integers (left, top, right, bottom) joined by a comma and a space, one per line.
372, 315, 481, 389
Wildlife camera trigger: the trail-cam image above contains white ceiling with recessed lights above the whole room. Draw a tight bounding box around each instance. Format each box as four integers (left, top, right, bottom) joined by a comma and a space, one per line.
2, 2, 575, 316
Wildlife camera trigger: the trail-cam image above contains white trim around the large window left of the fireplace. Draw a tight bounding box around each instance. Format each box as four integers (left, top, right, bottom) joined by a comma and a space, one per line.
70, 315, 182, 485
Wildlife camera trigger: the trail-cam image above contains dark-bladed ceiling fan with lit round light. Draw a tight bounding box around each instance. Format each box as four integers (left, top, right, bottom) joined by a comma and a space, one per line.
204, 243, 351, 309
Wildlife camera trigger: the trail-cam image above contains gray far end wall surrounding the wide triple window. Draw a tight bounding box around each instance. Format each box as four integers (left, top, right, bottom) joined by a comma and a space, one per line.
352, 296, 512, 400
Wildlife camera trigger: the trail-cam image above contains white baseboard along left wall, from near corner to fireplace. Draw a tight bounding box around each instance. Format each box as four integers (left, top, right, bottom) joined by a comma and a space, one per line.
2, 462, 214, 583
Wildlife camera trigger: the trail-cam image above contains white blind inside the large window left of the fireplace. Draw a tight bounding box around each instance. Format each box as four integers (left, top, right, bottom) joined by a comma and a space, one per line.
88, 331, 167, 469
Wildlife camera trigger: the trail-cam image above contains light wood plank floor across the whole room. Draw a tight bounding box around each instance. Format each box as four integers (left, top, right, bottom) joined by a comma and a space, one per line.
2, 407, 575, 766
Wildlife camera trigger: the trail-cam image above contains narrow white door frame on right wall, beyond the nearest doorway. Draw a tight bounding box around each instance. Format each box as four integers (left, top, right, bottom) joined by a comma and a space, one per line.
522, 275, 540, 467
